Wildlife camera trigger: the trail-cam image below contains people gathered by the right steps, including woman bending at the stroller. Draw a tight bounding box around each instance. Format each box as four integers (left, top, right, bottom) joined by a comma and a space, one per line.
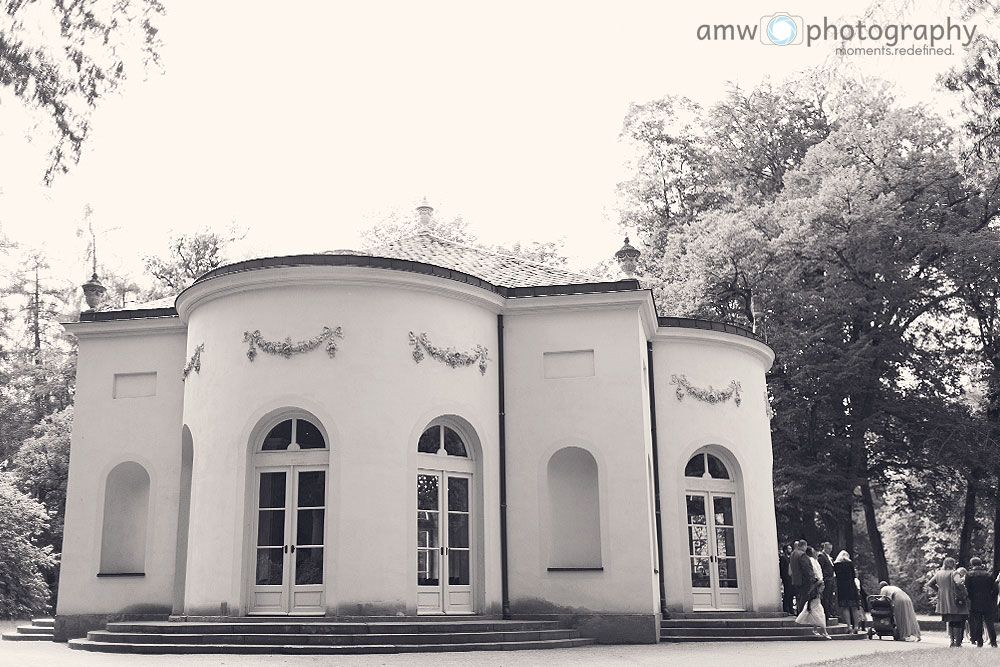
778, 540, 920, 641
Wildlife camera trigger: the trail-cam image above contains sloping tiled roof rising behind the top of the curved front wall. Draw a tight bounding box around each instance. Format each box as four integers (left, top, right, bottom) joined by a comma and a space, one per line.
368, 232, 602, 287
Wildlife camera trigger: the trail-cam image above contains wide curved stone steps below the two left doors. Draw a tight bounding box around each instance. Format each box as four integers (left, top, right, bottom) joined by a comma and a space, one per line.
69, 616, 594, 655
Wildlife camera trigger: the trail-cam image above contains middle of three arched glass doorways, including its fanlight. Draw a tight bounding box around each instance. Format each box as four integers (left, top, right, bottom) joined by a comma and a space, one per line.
416, 421, 476, 614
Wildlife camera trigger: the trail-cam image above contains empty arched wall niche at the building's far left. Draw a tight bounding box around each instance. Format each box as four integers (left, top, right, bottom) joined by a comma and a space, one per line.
100, 461, 149, 574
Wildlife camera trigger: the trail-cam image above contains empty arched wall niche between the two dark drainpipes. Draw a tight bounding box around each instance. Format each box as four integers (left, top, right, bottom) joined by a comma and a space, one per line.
547, 447, 602, 568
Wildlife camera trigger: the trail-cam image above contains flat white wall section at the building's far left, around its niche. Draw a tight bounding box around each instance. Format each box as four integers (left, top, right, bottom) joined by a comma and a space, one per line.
57, 318, 185, 614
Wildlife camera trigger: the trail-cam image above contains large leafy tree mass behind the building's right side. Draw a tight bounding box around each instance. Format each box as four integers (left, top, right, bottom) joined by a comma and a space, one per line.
620, 75, 1000, 578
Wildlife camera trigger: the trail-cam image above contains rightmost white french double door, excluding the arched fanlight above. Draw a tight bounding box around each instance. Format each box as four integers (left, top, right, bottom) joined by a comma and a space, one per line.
685, 491, 743, 611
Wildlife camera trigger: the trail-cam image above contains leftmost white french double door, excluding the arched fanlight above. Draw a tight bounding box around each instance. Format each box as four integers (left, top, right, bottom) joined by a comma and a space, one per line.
250, 465, 327, 614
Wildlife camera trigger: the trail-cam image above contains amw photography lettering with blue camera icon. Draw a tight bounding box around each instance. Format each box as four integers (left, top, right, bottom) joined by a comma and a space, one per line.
696, 12, 978, 55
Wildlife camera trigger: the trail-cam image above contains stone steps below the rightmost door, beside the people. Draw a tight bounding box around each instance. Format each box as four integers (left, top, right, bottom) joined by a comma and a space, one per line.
660, 612, 867, 642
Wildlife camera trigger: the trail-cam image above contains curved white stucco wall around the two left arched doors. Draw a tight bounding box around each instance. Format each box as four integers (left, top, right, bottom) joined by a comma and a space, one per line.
179, 267, 500, 615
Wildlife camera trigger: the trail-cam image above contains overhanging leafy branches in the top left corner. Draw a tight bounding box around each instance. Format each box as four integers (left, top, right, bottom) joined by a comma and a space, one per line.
0, 0, 165, 185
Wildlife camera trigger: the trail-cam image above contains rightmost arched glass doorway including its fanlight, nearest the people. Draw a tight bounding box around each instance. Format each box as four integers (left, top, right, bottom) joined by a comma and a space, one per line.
684, 449, 744, 611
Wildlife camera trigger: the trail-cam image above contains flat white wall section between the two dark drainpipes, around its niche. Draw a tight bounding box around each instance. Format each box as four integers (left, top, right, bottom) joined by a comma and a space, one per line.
504, 295, 658, 614
